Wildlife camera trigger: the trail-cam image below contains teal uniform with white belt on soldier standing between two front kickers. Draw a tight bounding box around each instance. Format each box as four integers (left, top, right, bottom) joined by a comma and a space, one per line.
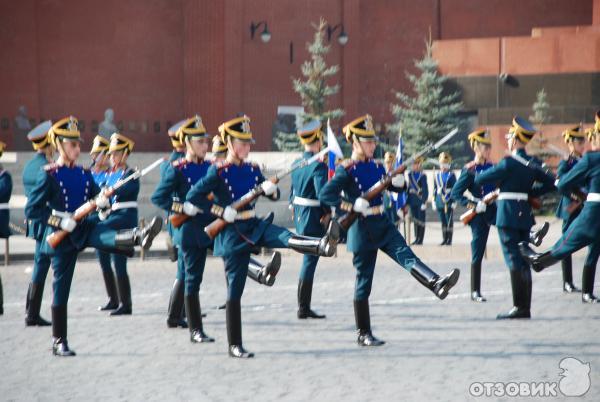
290, 152, 327, 282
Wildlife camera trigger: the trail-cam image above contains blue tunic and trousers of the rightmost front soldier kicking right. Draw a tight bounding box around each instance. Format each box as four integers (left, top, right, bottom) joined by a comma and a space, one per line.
319, 160, 420, 300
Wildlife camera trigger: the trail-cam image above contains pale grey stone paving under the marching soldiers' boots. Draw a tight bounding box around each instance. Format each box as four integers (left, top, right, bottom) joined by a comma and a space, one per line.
0, 248, 600, 401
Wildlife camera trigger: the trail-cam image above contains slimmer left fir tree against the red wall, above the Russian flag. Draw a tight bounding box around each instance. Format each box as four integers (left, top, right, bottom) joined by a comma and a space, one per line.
274, 18, 344, 151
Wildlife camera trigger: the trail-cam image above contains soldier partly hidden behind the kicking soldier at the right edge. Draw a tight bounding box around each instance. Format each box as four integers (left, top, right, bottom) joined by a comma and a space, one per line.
556, 125, 585, 293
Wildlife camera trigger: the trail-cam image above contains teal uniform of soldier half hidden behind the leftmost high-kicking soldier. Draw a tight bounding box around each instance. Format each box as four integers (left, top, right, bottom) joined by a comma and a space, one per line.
23, 152, 50, 285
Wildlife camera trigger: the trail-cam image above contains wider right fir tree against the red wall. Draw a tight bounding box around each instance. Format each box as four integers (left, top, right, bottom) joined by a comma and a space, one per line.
388, 35, 462, 155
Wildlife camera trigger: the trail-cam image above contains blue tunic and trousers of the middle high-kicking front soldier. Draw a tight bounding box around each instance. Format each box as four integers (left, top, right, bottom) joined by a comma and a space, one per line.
186, 162, 292, 301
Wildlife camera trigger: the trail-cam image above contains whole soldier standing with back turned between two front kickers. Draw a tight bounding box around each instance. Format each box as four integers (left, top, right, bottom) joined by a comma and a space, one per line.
290, 120, 327, 319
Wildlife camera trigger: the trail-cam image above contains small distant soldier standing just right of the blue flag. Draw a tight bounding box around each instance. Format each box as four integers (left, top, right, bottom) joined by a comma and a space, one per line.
407, 157, 429, 245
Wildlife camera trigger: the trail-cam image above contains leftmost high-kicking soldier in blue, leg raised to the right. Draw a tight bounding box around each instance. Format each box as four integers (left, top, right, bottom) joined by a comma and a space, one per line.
25, 116, 162, 356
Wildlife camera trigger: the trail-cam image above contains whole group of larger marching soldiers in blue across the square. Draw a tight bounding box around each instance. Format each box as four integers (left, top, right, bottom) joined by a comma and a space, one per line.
2, 110, 600, 357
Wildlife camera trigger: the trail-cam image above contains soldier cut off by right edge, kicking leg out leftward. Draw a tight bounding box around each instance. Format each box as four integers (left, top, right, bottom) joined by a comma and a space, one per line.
520, 118, 600, 304
